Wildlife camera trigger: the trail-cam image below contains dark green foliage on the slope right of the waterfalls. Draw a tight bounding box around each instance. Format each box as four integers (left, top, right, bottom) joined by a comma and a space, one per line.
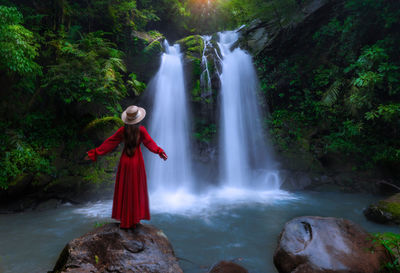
256, 0, 400, 170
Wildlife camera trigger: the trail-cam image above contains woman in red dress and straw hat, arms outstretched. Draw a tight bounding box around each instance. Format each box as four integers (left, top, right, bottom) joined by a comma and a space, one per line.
85, 105, 168, 228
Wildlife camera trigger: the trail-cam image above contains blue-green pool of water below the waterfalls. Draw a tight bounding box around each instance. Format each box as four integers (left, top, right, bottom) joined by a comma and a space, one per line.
0, 191, 399, 273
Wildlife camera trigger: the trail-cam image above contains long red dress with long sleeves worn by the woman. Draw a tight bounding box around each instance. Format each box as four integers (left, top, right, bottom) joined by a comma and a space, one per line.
88, 126, 163, 228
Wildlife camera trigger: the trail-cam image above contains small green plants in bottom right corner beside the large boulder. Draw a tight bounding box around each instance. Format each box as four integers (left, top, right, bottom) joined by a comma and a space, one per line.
372, 232, 400, 273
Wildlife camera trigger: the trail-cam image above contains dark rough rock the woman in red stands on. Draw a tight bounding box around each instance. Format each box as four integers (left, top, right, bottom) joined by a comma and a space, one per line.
54, 223, 182, 273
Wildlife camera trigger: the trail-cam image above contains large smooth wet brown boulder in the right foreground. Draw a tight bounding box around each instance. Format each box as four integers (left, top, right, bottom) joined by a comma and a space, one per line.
274, 216, 390, 273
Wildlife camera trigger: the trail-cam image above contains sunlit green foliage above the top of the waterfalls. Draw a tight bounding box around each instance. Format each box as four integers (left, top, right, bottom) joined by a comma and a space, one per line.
133, 0, 309, 37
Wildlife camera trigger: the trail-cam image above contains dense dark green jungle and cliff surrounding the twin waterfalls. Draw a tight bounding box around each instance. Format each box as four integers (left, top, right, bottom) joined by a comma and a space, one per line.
0, 0, 400, 272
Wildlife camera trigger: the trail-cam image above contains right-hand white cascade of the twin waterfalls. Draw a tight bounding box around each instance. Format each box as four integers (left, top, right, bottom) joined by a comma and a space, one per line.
218, 28, 280, 190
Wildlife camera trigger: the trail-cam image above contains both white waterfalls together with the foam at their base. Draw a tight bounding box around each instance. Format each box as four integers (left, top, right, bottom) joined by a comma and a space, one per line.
69, 32, 288, 219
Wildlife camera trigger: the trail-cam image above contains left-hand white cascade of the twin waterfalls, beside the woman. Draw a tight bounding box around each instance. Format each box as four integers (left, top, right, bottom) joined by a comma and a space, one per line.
146, 41, 192, 192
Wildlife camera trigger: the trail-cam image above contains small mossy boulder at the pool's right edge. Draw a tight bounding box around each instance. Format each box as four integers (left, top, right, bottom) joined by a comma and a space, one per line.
364, 193, 400, 225
